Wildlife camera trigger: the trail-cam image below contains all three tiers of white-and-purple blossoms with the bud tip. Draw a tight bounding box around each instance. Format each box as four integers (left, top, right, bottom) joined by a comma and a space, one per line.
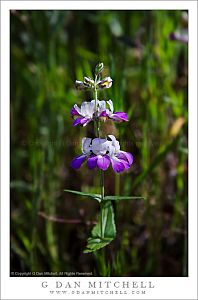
71, 63, 133, 173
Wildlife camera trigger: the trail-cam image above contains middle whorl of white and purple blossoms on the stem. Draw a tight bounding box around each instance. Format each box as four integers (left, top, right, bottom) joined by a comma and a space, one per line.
71, 100, 128, 126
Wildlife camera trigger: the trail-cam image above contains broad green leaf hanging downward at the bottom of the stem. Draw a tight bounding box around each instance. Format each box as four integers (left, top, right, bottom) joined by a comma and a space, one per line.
84, 201, 116, 253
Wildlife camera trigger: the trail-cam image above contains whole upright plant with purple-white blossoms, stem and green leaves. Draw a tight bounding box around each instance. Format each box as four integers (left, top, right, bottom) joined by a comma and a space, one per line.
66, 63, 137, 253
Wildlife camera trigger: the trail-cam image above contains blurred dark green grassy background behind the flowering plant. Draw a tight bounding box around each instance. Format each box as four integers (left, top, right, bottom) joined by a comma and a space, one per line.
10, 10, 188, 276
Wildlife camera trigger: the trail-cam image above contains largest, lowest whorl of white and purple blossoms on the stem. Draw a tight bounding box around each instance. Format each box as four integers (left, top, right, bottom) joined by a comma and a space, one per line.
71, 135, 133, 173
